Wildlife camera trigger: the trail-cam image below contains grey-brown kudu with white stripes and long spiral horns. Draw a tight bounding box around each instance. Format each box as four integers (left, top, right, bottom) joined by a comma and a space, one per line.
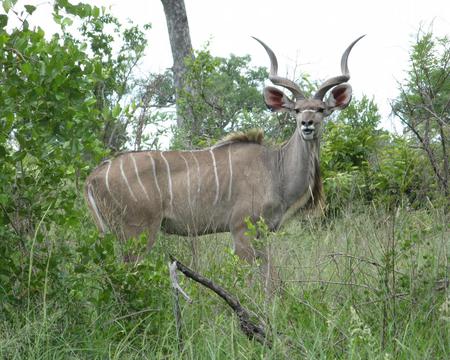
85, 37, 362, 268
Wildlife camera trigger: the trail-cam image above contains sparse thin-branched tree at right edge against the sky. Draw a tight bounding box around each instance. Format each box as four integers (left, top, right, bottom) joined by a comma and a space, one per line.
392, 31, 450, 197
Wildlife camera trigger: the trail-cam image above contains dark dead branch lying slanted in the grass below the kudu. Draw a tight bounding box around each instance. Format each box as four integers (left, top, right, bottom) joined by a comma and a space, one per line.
169, 255, 272, 348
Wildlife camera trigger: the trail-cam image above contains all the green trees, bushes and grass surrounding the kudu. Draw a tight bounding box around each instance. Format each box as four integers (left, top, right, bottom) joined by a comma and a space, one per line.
0, 0, 450, 359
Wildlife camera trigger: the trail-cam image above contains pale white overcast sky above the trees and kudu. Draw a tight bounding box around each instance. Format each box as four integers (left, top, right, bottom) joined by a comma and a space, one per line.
7, 0, 450, 130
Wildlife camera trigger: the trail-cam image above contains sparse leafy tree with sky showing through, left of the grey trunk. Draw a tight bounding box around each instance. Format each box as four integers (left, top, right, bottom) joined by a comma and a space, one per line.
53, 0, 150, 152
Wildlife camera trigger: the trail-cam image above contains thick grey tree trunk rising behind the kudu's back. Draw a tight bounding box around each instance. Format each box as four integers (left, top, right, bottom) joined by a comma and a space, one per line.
161, 0, 193, 127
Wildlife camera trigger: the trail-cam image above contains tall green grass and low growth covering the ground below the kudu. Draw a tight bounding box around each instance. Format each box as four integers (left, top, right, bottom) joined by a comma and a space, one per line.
0, 207, 450, 359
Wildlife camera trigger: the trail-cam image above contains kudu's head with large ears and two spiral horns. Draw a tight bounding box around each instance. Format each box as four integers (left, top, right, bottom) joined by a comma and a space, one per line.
254, 35, 364, 141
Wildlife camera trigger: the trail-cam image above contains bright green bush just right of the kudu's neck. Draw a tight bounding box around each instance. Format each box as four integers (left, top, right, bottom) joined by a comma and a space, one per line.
320, 97, 389, 211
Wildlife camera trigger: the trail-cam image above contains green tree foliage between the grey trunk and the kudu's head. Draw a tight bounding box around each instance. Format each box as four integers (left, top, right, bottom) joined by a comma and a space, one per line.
174, 49, 267, 147
